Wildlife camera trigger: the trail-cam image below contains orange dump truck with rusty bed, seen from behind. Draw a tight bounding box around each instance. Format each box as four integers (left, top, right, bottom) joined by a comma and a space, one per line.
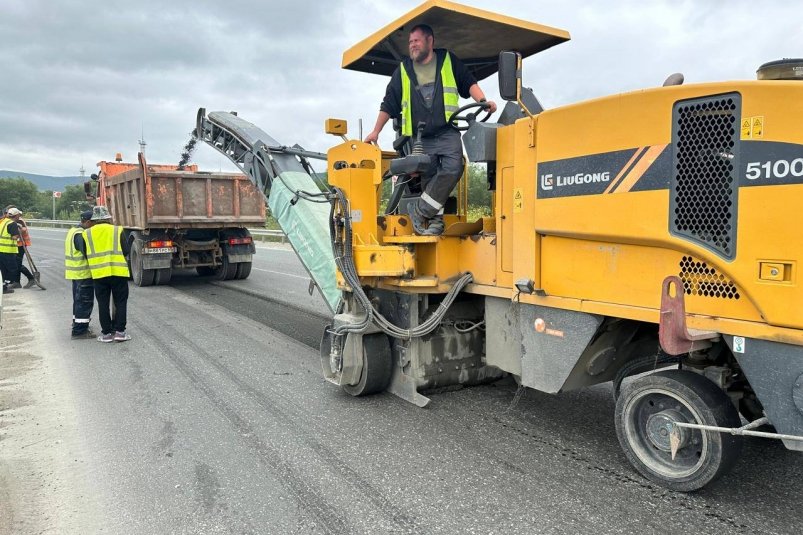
90, 153, 265, 286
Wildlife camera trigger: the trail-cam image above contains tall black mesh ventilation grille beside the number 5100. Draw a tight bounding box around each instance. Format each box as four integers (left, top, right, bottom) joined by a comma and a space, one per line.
670, 93, 741, 259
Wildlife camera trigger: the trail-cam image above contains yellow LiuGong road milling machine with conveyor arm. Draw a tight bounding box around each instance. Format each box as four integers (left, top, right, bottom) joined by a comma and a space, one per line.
197, 0, 803, 491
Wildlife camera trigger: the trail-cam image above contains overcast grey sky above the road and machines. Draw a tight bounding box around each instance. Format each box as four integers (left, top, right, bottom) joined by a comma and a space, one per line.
0, 0, 803, 176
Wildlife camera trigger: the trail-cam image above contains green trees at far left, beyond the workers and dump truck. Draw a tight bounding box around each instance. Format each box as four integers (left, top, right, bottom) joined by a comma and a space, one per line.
0, 178, 92, 220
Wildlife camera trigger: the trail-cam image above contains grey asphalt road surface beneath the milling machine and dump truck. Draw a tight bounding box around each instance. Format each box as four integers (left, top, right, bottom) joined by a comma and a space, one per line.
0, 230, 803, 534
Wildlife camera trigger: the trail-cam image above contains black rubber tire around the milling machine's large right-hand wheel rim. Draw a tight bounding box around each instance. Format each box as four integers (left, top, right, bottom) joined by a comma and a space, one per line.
615, 370, 742, 492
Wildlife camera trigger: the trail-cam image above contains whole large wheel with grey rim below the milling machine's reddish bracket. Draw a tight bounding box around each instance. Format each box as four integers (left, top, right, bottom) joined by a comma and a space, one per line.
616, 370, 742, 492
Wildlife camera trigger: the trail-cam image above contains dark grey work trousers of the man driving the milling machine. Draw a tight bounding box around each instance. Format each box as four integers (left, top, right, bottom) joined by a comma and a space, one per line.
418, 128, 463, 219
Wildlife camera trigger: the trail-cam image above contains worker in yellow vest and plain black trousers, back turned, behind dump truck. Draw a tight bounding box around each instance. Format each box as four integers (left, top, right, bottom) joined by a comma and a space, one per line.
83, 206, 131, 342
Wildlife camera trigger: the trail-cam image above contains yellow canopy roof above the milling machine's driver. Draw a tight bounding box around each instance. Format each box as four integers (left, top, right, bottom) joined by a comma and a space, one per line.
343, 0, 570, 80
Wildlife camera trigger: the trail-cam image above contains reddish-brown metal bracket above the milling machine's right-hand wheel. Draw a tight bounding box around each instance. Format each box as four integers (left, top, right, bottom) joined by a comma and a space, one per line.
658, 275, 719, 355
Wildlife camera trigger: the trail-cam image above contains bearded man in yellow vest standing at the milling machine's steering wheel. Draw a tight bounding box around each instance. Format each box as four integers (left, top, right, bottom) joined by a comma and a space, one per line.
365, 24, 496, 236
